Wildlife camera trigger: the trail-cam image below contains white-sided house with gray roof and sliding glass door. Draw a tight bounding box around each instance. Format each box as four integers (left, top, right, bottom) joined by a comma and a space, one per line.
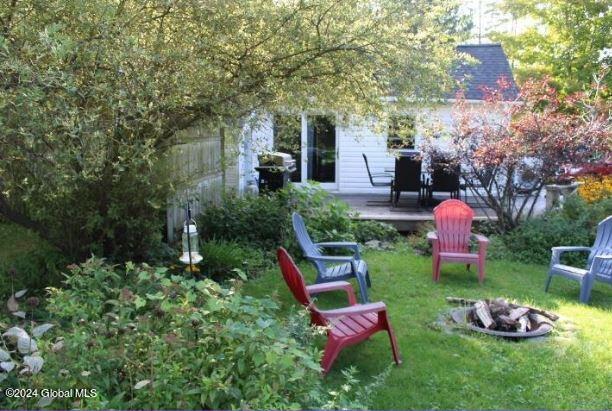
240, 44, 518, 193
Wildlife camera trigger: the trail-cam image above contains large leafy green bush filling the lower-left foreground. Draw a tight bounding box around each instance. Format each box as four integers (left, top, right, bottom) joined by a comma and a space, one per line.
2, 259, 376, 409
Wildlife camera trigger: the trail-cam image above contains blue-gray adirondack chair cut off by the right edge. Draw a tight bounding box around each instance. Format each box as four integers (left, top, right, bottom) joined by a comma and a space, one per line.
544, 216, 612, 304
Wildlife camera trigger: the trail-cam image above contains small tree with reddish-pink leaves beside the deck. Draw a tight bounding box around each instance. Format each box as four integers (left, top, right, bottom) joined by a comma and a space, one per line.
428, 79, 612, 231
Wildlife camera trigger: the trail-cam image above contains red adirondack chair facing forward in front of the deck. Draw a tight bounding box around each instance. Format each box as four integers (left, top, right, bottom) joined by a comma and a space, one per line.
427, 200, 489, 283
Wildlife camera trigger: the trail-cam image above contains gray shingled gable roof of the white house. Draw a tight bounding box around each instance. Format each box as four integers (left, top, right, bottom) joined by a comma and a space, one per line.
449, 44, 518, 100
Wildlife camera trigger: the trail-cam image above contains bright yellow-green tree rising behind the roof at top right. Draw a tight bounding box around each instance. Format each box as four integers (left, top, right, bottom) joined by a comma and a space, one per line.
490, 0, 612, 92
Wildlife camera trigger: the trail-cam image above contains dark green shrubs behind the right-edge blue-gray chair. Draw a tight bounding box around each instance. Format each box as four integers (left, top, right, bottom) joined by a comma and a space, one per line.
503, 196, 612, 267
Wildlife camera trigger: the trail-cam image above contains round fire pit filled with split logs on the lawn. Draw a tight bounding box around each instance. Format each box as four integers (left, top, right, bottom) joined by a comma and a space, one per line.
446, 297, 559, 339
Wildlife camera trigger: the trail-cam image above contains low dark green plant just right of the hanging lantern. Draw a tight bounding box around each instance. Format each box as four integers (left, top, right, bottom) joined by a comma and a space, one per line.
200, 239, 269, 280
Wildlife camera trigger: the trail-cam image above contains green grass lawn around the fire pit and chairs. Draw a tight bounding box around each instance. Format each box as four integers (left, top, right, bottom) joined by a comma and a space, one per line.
245, 246, 612, 409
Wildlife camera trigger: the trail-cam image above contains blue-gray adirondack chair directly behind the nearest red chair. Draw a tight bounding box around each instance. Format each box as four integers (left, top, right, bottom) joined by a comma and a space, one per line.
293, 213, 372, 304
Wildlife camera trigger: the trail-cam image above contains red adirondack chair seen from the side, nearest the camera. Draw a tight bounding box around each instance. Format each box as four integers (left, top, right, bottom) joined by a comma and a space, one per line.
276, 247, 402, 373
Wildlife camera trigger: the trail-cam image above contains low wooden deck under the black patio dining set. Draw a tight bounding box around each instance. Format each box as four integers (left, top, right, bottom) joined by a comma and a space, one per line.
332, 193, 496, 231
